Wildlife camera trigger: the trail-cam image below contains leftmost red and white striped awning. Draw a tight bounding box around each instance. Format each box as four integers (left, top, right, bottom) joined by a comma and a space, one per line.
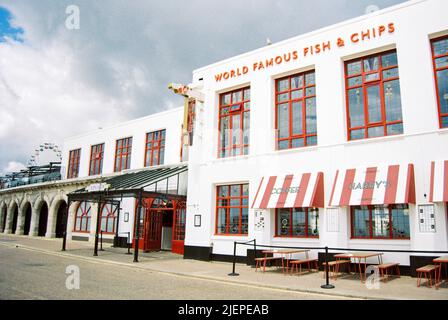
248, 172, 324, 209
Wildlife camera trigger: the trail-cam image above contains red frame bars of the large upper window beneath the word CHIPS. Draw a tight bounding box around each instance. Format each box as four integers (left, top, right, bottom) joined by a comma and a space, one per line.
344, 49, 403, 141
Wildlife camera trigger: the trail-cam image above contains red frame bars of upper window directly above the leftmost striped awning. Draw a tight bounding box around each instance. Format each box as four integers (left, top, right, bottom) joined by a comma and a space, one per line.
275, 70, 317, 150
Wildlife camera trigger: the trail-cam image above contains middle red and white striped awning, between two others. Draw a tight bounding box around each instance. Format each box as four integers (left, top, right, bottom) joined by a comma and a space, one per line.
329, 164, 415, 206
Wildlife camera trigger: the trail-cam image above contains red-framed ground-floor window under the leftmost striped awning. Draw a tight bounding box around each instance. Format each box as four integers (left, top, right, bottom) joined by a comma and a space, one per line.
275, 208, 319, 238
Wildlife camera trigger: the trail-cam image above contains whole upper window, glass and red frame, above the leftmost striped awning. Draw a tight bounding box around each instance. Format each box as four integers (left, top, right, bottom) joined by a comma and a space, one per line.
275, 71, 317, 150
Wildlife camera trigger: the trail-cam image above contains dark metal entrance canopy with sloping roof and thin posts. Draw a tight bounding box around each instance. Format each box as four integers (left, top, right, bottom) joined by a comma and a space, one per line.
62, 165, 188, 262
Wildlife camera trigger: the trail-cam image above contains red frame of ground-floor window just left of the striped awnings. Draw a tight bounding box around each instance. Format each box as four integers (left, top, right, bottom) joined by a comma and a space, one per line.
215, 184, 249, 236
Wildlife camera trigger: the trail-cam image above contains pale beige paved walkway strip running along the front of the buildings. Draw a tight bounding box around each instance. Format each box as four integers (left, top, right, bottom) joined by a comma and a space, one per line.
0, 234, 448, 300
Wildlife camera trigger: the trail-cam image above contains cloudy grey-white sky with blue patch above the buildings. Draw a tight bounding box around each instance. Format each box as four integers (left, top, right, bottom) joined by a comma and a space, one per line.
0, 0, 404, 175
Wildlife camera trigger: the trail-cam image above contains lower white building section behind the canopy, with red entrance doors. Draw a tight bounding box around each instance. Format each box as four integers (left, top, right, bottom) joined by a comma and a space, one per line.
62, 108, 187, 253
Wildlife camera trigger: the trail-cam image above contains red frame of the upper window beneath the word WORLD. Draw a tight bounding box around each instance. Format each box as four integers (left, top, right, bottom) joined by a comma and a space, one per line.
218, 87, 250, 158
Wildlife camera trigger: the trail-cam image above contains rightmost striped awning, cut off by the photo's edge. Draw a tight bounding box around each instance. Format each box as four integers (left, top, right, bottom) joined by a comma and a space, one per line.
429, 160, 448, 202
